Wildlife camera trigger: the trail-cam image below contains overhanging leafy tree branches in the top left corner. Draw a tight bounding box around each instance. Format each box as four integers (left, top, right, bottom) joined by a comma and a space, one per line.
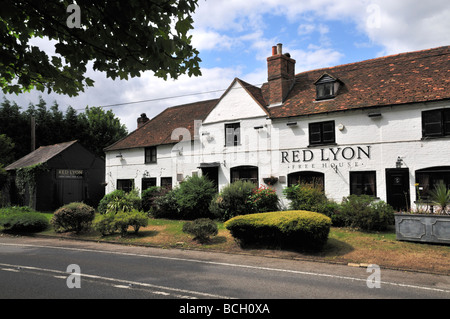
0, 0, 201, 96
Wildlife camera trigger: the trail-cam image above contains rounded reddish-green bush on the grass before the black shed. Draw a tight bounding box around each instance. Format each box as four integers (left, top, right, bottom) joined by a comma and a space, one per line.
50, 202, 95, 233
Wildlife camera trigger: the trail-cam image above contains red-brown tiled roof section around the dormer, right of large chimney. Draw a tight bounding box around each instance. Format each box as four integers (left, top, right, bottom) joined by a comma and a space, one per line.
268, 46, 450, 118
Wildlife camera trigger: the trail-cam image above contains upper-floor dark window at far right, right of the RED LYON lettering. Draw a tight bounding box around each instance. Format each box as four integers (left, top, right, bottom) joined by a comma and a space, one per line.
422, 109, 450, 137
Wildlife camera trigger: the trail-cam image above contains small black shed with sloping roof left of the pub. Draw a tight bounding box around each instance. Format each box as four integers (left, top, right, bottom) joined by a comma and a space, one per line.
6, 140, 105, 211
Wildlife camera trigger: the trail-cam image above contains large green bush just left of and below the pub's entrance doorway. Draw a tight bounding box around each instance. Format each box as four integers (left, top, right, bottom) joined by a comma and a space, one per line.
153, 176, 216, 220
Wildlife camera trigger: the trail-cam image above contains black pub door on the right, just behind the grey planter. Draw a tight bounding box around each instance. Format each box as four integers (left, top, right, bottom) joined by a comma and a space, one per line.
386, 168, 410, 211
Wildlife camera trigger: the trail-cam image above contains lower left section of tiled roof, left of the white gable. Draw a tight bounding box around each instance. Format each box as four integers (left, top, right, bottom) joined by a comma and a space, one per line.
105, 99, 218, 151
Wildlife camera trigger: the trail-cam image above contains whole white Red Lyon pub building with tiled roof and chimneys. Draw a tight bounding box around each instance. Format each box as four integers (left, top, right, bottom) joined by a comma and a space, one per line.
105, 44, 450, 210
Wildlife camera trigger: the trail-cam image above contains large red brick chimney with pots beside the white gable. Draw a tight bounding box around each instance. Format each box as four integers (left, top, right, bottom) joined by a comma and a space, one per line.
267, 43, 295, 106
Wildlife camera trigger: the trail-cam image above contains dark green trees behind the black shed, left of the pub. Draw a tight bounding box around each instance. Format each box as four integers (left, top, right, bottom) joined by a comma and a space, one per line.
0, 98, 127, 159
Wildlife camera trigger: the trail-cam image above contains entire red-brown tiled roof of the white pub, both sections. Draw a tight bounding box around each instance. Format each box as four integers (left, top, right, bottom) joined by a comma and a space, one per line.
105, 46, 450, 151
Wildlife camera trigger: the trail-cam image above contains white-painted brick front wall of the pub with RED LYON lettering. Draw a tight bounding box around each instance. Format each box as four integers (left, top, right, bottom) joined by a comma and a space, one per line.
106, 82, 450, 211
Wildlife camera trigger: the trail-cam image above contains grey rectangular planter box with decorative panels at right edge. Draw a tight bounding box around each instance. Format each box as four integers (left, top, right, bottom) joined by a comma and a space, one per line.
395, 214, 450, 244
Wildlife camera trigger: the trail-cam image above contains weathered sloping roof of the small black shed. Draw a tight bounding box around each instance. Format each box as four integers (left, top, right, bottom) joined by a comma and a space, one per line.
6, 140, 77, 171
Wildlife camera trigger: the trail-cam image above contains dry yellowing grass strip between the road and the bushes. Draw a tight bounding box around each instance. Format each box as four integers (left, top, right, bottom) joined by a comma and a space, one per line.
29, 214, 450, 275
